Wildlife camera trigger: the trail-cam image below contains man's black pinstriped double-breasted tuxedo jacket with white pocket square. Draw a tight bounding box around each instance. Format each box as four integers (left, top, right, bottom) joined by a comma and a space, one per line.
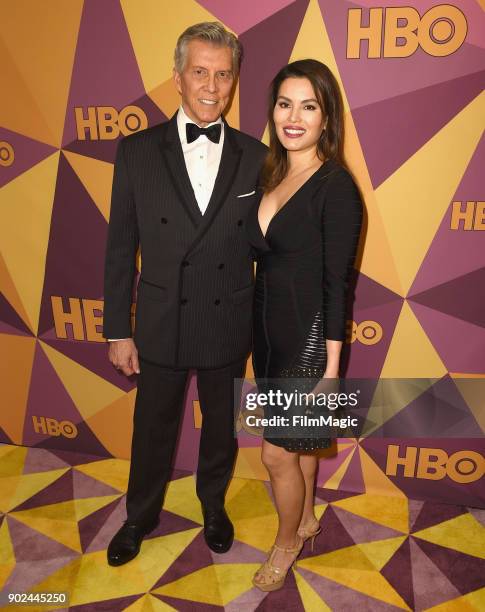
103, 115, 266, 368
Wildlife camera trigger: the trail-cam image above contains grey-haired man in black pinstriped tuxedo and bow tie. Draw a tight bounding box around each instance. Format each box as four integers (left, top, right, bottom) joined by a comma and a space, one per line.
103, 22, 266, 565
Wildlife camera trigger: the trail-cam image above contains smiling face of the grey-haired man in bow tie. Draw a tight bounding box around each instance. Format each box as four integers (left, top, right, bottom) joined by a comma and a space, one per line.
173, 39, 234, 127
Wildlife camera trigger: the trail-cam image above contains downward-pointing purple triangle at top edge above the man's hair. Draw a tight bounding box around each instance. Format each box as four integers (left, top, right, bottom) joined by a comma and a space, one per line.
197, 0, 294, 36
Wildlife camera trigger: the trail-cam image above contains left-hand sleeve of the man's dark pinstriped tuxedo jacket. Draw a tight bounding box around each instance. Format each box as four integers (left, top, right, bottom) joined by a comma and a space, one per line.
103, 140, 139, 338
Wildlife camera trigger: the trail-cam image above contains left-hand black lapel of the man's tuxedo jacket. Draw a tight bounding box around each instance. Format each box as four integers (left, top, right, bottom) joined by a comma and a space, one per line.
159, 113, 202, 227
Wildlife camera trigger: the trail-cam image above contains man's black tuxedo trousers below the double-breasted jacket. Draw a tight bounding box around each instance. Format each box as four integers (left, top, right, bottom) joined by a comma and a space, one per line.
126, 359, 246, 524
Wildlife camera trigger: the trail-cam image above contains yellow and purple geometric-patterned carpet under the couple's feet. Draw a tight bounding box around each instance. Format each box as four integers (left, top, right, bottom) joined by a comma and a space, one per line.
0, 445, 485, 612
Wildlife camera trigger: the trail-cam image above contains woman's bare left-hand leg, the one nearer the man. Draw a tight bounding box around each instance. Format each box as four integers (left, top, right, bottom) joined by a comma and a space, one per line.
253, 440, 305, 580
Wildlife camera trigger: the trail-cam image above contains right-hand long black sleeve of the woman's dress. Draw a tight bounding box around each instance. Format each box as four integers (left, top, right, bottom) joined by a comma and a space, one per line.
322, 169, 363, 341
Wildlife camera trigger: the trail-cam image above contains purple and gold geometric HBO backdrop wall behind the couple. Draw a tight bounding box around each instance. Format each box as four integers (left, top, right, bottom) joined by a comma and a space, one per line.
0, 0, 485, 507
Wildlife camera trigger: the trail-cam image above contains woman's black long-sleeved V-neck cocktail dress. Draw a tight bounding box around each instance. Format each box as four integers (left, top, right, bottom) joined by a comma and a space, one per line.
246, 160, 363, 451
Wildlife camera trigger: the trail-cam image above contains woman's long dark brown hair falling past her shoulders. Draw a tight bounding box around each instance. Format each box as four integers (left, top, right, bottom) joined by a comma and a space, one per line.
261, 59, 344, 192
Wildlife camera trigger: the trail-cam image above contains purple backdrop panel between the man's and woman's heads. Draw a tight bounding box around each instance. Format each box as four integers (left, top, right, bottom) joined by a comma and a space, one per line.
239, 0, 308, 139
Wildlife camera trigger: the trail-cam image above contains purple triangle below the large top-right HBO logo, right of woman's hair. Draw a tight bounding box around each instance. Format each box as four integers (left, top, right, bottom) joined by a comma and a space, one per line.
349, 69, 485, 188
